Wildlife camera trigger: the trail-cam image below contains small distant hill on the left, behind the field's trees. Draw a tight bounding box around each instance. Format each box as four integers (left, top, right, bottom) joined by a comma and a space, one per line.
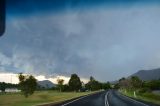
37, 80, 56, 88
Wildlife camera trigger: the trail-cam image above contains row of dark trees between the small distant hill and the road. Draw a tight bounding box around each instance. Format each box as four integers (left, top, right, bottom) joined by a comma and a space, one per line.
53, 74, 111, 92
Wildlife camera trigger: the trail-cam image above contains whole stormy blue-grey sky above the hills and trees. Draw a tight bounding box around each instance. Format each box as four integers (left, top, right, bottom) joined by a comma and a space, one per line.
0, 0, 160, 81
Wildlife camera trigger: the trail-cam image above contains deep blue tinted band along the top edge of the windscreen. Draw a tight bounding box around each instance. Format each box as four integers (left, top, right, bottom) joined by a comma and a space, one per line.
7, 0, 160, 16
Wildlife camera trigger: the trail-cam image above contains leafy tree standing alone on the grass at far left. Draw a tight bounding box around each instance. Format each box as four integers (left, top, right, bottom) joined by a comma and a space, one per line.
18, 73, 37, 97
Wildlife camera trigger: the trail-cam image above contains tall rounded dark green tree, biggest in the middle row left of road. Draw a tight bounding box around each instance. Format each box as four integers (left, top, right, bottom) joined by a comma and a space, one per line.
68, 74, 82, 91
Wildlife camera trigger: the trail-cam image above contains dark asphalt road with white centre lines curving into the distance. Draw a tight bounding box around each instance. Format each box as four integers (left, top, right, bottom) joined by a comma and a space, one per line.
59, 90, 156, 106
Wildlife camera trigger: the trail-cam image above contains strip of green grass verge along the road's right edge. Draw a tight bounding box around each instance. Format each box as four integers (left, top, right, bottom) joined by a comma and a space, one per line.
120, 90, 160, 105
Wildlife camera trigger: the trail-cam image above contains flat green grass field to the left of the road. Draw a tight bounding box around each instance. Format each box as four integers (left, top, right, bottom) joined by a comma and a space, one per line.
0, 91, 93, 106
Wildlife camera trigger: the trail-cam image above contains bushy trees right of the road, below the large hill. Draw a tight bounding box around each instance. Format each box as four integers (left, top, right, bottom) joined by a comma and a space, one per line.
114, 76, 160, 93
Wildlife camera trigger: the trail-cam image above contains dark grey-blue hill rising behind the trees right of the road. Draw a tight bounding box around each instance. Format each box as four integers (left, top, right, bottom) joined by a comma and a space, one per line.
131, 68, 160, 81
